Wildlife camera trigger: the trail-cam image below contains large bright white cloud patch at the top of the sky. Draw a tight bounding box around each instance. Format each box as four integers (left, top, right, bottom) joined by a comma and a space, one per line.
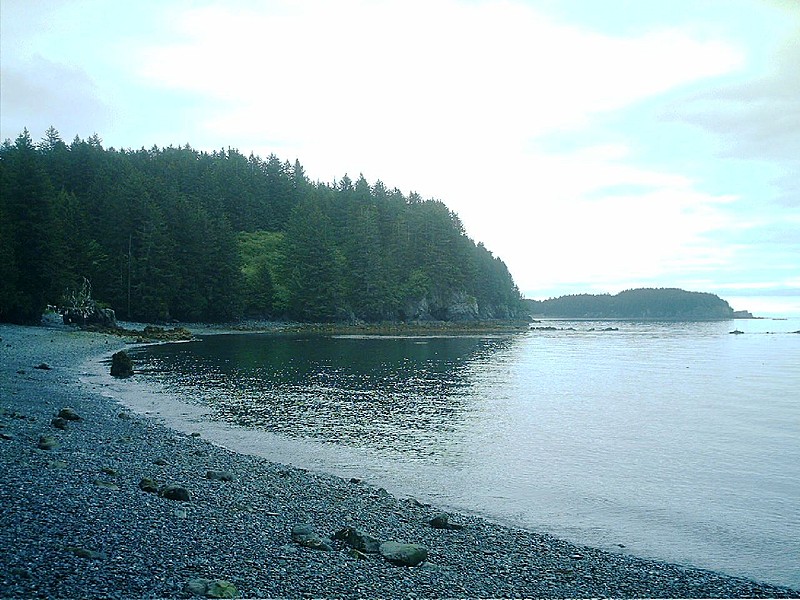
137, 0, 741, 164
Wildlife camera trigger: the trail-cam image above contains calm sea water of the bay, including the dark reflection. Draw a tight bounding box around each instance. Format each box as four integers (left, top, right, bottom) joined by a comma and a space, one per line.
125, 319, 800, 589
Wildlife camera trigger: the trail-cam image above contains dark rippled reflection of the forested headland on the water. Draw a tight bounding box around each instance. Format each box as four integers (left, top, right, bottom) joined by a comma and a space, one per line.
136, 334, 510, 457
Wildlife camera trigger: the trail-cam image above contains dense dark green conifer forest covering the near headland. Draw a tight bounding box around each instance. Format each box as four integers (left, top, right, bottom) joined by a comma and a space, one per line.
0, 128, 521, 322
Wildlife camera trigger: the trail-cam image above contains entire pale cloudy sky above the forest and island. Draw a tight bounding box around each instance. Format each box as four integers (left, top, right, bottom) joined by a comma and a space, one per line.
0, 0, 800, 316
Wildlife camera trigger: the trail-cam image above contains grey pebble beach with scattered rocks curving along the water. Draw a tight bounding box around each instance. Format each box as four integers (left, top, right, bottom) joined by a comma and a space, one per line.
0, 325, 800, 598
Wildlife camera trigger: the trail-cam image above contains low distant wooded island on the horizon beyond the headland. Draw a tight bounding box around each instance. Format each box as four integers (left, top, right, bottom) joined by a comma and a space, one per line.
524, 288, 754, 321
